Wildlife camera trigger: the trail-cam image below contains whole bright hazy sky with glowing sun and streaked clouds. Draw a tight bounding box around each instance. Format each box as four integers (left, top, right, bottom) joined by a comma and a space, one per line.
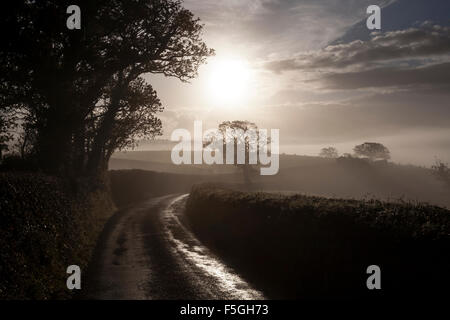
145, 0, 450, 166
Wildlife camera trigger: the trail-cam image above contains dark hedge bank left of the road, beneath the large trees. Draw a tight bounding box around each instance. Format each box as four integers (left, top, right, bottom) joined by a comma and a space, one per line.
0, 172, 113, 299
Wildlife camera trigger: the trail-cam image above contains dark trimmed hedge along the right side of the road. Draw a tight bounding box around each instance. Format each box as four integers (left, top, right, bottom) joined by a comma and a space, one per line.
186, 185, 450, 298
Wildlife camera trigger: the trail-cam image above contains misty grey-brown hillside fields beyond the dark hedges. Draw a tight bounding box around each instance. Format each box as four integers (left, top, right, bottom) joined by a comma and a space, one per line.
110, 151, 450, 207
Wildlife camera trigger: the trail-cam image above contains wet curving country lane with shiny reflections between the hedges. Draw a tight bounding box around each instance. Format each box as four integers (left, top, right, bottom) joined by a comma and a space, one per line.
83, 195, 264, 299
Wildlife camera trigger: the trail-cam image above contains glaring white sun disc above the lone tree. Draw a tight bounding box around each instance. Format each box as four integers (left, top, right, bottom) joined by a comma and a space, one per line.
208, 59, 250, 107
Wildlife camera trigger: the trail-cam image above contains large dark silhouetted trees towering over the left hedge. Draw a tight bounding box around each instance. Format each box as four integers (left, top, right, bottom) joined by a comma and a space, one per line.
0, 0, 213, 175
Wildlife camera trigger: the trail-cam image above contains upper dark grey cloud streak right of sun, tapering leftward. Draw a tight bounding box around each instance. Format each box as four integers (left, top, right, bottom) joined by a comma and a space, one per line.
265, 25, 450, 73
